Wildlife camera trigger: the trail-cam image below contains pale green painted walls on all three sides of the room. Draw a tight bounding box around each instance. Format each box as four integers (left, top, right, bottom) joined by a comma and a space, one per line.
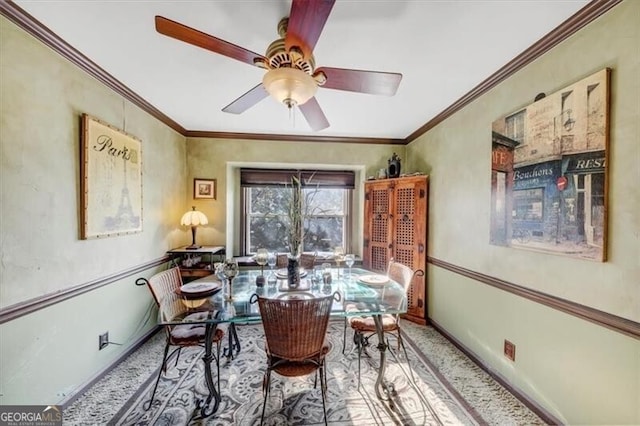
0, 0, 640, 424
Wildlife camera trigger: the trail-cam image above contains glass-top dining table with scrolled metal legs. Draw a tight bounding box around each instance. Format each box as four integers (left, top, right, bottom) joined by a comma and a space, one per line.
158, 267, 407, 417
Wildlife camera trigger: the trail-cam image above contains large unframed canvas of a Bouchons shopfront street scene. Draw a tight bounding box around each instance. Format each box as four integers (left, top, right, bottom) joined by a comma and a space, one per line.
490, 68, 611, 262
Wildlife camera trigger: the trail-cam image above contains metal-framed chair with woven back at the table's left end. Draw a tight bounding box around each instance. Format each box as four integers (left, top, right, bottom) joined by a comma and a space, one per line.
136, 267, 224, 410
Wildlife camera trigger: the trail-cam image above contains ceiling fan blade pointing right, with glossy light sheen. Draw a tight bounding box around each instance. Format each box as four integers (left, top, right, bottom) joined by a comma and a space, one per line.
316, 67, 402, 96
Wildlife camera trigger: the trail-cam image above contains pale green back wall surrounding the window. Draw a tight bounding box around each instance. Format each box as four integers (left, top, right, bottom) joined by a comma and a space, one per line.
187, 138, 404, 255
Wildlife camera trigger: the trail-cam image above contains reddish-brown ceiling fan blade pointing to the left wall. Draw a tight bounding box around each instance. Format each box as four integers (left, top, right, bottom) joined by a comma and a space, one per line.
156, 16, 264, 65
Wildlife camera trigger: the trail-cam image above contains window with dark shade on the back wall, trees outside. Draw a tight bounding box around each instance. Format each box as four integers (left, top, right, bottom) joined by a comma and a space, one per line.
240, 169, 354, 255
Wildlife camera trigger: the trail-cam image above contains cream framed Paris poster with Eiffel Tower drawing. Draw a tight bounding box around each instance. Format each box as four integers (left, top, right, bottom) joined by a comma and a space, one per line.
80, 114, 142, 239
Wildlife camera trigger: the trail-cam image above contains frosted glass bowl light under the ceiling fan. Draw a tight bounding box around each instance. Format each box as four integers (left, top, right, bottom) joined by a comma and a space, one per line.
262, 68, 318, 108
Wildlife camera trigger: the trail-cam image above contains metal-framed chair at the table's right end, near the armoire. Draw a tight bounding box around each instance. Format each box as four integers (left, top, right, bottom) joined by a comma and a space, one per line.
342, 259, 424, 386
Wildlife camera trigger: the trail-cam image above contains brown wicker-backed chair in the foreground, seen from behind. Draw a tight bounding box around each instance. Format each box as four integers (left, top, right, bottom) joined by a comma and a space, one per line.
252, 292, 340, 424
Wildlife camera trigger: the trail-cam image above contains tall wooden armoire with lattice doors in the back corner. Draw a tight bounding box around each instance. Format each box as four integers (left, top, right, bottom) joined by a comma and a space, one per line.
362, 176, 428, 324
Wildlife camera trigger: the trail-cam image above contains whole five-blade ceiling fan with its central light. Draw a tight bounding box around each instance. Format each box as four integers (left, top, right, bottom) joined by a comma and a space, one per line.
155, 0, 402, 131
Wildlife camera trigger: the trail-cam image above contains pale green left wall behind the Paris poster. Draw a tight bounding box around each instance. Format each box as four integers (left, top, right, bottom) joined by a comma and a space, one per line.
0, 17, 189, 404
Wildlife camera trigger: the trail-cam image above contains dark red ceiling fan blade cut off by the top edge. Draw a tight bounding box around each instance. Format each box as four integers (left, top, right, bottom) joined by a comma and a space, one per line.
284, 0, 335, 58
